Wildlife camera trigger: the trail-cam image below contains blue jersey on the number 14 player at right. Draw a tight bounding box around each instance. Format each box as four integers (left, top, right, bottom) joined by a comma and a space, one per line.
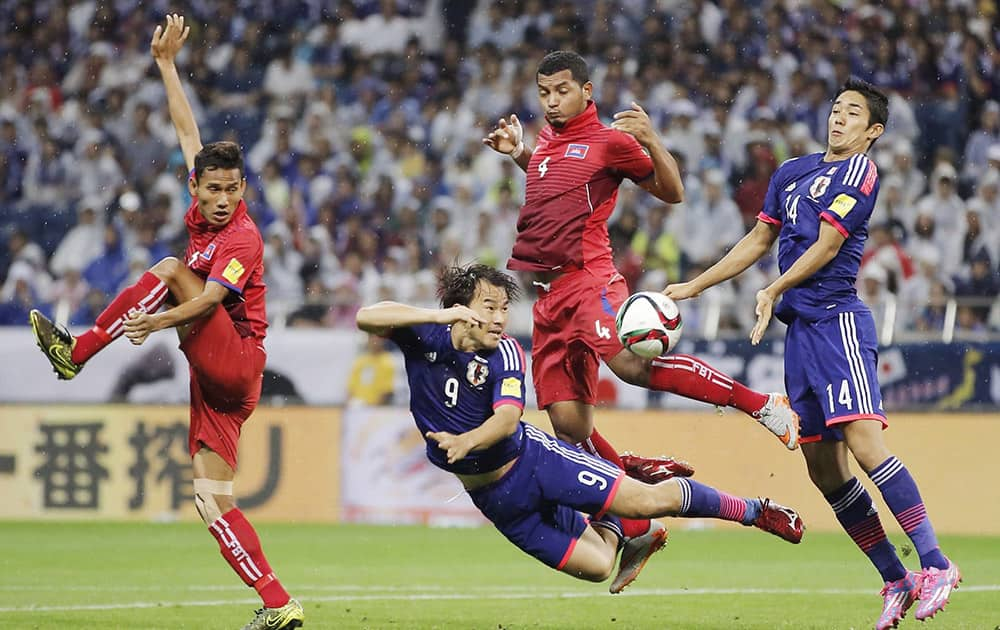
757, 153, 879, 323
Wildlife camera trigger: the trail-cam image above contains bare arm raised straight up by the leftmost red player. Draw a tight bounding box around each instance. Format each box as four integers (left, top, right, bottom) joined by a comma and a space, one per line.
149, 13, 202, 170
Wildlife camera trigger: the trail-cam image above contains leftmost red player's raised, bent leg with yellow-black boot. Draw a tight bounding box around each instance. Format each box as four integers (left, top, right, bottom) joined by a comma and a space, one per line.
30, 257, 205, 380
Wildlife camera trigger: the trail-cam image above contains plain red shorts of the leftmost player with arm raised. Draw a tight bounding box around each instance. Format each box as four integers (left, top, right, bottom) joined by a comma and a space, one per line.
181, 306, 267, 470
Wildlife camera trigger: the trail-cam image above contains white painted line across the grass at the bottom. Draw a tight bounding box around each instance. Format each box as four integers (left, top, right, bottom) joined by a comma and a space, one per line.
0, 584, 1000, 613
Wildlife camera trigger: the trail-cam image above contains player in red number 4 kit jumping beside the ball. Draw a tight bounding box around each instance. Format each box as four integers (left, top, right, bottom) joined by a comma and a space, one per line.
483, 51, 798, 554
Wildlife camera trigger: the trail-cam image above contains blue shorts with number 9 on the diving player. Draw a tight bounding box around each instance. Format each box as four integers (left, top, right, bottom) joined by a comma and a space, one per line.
469, 424, 625, 569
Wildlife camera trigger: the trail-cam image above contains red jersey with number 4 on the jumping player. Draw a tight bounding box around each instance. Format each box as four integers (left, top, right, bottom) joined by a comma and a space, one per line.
507, 102, 653, 271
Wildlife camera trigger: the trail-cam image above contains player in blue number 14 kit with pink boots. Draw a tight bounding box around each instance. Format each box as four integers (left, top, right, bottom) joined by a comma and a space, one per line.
664, 79, 961, 629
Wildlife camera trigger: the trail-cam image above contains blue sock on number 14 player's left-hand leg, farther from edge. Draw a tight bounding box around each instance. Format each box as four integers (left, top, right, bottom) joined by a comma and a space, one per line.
825, 477, 906, 582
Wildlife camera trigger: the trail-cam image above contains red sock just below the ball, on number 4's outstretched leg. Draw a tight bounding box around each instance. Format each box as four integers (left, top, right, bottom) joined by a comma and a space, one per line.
649, 354, 767, 416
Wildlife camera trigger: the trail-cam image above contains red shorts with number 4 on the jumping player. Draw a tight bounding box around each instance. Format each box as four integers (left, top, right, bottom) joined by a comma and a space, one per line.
531, 267, 629, 409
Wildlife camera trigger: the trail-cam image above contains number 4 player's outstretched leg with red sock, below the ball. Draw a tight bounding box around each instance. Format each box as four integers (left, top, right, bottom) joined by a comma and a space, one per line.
607, 349, 799, 450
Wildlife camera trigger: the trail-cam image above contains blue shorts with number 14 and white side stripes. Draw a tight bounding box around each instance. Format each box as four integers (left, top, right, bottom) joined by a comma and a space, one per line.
785, 311, 888, 444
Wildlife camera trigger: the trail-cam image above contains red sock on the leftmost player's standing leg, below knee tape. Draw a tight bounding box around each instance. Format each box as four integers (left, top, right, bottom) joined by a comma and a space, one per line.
208, 508, 290, 608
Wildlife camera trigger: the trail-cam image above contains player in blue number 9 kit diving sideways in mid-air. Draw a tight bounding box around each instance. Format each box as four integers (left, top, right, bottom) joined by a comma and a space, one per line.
357, 265, 803, 593
